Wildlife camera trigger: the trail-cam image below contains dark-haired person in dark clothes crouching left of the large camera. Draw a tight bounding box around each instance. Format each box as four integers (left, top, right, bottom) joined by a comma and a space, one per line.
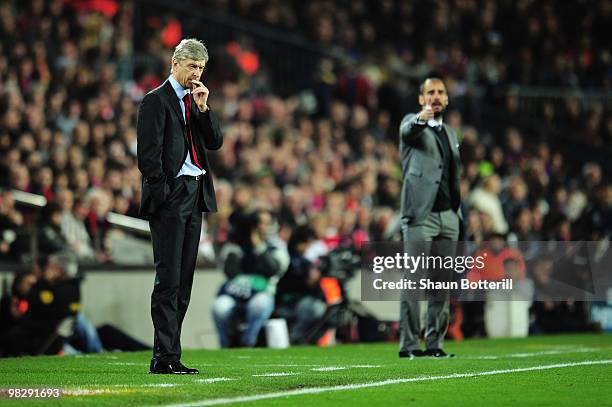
276, 226, 327, 344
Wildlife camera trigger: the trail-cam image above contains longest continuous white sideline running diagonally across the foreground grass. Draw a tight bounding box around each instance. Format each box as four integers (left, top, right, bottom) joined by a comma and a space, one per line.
165, 359, 612, 407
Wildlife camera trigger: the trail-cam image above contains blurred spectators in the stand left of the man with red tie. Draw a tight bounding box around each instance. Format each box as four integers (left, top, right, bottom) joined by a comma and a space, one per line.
0, 0, 140, 261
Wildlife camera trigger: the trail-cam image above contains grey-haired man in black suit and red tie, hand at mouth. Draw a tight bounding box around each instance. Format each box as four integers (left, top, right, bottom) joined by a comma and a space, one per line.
137, 39, 223, 374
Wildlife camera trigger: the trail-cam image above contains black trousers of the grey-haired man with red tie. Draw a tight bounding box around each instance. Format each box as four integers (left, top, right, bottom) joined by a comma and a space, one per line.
149, 175, 205, 362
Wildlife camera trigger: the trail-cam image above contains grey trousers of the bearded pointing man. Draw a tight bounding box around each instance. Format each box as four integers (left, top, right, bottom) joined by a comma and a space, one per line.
400, 210, 460, 351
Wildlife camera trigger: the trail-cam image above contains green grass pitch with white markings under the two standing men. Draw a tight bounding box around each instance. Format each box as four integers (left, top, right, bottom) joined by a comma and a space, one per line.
0, 334, 612, 407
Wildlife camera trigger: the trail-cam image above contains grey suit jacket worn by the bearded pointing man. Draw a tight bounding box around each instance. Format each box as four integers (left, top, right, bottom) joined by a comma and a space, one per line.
400, 113, 461, 223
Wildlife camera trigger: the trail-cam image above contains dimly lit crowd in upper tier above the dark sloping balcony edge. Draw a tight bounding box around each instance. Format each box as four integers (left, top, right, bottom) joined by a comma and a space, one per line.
218, 0, 612, 89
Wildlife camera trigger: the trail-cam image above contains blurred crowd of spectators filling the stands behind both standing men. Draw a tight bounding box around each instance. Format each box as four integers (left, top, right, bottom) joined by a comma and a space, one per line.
0, 0, 612, 346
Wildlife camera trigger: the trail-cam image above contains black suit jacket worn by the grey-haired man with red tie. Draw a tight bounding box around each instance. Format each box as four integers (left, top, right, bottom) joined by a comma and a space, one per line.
137, 80, 223, 217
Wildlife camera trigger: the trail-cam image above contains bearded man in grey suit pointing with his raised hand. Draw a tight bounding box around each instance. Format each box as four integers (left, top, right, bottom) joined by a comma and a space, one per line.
399, 78, 461, 359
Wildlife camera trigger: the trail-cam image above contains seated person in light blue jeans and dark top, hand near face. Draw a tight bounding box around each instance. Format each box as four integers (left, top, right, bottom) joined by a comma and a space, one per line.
212, 209, 289, 348
